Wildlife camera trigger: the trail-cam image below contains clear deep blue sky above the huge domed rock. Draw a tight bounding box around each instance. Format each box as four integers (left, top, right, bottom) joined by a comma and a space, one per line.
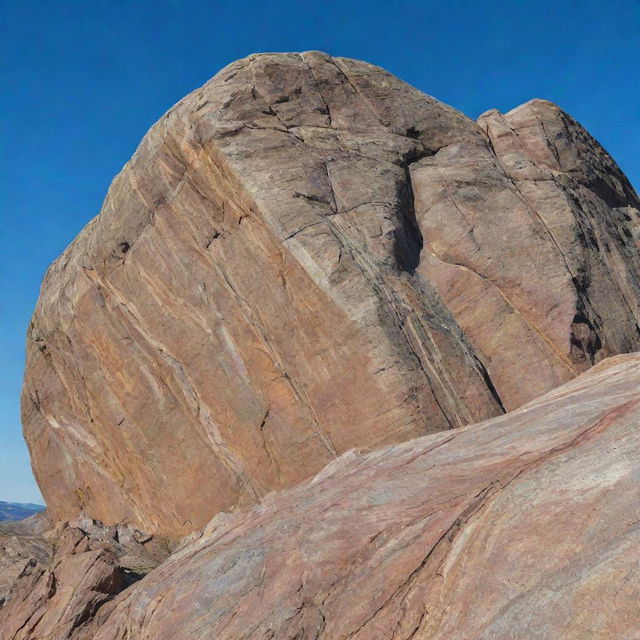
0, 0, 640, 501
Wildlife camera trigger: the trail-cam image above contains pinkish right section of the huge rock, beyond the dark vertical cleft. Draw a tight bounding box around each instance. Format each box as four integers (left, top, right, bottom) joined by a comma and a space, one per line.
411, 100, 640, 409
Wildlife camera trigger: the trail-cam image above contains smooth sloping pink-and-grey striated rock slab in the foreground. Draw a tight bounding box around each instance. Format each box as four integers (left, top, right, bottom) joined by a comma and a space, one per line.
72, 354, 640, 640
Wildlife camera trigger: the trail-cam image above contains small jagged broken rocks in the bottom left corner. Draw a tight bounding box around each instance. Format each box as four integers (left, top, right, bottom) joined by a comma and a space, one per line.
0, 518, 169, 640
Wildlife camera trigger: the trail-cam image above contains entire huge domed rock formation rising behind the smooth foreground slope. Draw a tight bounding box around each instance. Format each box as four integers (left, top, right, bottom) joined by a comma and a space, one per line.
23, 52, 640, 535
